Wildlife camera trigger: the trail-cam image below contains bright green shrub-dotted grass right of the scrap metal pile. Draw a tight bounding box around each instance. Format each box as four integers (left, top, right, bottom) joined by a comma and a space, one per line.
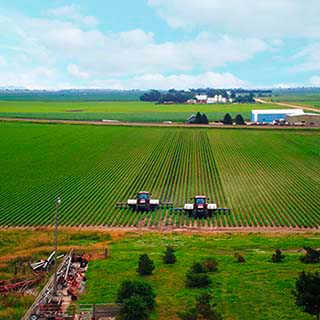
79, 234, 320, 320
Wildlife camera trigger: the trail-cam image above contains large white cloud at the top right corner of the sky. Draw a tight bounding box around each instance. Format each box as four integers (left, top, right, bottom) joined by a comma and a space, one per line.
148, 0, 320, 37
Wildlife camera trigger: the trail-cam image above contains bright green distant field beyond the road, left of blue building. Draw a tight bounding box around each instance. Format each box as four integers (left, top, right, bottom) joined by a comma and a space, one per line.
0, 101, 279, 122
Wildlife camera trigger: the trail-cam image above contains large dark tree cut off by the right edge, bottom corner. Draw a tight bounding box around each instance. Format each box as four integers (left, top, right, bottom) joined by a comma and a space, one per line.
293, 272, 320, 320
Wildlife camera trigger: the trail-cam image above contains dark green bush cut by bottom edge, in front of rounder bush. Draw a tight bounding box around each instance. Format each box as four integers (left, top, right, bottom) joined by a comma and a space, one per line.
119, 295, 148, 320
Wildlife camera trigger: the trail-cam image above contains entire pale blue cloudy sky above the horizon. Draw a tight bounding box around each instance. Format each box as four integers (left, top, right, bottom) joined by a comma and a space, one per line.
0, 0, 320, 90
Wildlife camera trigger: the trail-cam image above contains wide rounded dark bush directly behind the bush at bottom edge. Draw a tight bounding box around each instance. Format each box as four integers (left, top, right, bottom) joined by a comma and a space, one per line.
116, 280, 156, 310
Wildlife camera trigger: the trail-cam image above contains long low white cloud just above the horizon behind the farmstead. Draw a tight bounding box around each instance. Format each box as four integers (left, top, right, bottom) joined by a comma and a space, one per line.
91, 72, 248, 90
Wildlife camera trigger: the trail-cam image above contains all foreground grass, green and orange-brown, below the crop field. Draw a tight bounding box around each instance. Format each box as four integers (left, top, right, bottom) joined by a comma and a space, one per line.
0, 228, 320, 320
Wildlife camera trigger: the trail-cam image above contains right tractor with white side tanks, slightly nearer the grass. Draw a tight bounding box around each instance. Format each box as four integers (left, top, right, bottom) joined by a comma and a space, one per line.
172, 195, 230, 218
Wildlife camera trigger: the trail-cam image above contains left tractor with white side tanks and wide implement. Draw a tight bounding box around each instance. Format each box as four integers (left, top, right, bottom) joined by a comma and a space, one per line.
116, 191, 173, 212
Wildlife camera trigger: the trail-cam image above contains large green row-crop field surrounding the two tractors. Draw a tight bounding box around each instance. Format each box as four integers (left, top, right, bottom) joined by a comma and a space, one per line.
0, 123, 320, 229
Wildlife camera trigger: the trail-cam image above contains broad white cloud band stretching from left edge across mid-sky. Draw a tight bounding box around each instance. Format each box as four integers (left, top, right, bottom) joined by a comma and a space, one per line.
0, 12, 267, 78
